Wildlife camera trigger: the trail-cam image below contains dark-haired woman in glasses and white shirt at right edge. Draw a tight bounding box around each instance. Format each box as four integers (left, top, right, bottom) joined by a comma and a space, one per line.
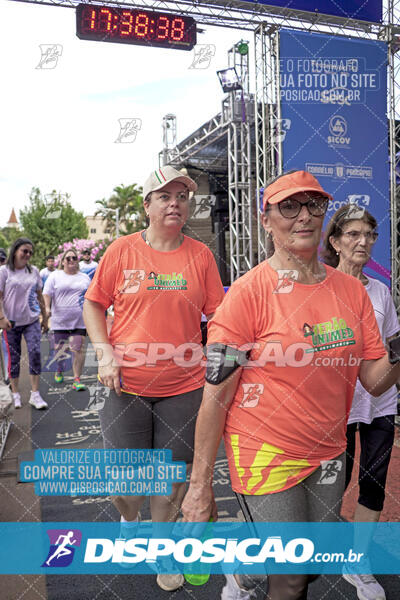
324, 204, 400, 600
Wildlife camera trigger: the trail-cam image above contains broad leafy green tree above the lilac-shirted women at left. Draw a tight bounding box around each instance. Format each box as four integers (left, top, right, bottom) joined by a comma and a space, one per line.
20, 188, 88, 267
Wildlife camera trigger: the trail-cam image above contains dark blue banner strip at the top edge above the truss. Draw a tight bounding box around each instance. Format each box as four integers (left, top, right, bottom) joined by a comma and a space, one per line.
241, 0, 382, 22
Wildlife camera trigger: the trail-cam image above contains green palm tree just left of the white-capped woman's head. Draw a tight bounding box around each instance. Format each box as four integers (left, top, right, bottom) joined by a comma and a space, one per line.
95, 183, 146, 235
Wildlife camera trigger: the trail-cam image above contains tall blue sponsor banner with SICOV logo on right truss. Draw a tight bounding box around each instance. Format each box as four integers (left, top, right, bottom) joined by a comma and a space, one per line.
276, 29, 390, 284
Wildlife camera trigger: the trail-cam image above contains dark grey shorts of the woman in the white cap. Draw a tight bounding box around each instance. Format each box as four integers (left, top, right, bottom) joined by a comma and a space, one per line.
99, 387, 203, 463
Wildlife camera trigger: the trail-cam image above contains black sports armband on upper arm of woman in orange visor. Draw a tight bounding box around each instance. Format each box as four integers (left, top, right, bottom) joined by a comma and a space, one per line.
206, 344, 250, 385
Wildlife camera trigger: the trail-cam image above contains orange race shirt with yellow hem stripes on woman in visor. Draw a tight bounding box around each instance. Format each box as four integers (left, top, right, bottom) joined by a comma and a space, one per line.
208, 261, 386, 495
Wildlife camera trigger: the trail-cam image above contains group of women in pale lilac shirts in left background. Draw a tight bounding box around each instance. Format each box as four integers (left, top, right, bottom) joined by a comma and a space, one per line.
0, 237, 97, 410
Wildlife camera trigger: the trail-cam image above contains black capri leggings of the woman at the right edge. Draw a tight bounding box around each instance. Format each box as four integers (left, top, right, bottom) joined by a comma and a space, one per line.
346, 415, 394, 511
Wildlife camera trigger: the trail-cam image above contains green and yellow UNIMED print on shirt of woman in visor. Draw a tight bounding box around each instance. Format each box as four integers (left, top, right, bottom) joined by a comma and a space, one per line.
303, 317, 356, 352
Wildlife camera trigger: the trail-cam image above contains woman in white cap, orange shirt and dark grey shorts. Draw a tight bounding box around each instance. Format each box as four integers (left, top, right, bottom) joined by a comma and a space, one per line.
84, 166, 224, 591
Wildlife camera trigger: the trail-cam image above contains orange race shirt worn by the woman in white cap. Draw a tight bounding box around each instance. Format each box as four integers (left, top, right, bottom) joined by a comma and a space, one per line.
85, 233, 224, 397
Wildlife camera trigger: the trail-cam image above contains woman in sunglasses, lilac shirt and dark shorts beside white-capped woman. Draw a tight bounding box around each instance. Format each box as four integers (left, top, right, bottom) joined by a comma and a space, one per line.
43, 248, 90, 392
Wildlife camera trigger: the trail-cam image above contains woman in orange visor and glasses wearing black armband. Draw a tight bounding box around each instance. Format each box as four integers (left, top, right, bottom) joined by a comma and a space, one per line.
182, 171, 400, 600
